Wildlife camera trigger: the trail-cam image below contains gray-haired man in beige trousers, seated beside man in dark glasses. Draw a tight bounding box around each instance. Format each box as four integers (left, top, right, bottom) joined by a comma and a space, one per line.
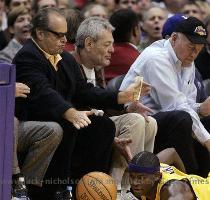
73, 17, 157, 194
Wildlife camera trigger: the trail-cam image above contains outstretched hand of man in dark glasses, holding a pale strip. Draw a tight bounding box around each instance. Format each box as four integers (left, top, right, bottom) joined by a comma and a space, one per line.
118, 79, 151, 104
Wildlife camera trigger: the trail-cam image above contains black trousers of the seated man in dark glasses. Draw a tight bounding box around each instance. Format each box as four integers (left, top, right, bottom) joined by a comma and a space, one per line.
45, 115, 115, 187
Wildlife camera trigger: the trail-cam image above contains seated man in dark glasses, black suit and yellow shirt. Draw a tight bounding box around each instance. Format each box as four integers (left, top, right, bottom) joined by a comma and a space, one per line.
13, 8, 139, 199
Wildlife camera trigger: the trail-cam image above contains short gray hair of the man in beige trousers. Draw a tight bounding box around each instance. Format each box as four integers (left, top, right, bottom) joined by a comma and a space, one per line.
75, 17, 114, 48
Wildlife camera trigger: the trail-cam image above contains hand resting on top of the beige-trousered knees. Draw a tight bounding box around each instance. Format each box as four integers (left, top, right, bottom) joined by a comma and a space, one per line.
126, 101, 153, 122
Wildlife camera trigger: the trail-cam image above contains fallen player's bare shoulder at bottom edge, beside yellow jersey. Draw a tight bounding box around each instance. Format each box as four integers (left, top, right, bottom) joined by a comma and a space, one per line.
160, 180, 196, 200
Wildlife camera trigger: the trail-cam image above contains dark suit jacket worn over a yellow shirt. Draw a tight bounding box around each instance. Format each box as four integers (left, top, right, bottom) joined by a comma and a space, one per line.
13, 40, 118, 121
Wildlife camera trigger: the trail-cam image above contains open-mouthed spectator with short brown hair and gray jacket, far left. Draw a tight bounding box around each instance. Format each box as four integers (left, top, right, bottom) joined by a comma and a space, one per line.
0, 6, 31, 63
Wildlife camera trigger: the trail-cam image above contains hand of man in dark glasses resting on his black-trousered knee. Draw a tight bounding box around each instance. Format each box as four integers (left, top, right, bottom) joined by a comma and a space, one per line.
64, 108, 94, 129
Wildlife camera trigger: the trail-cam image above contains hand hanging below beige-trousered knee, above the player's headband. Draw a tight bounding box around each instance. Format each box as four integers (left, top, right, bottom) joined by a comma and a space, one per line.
114, 137, 133, 162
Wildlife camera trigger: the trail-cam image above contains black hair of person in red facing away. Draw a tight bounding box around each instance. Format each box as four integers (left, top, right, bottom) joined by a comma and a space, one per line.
109, 9, 139, 42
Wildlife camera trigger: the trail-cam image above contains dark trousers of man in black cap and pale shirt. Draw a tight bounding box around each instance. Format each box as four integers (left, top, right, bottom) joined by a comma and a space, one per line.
153, 110, 198, 174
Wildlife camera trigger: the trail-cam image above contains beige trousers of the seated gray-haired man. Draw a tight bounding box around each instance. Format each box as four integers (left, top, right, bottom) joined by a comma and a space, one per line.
110, 113, 157, 190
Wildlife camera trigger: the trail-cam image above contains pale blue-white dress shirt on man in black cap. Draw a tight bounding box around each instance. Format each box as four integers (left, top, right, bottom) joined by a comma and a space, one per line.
120, 40, 210, 143
